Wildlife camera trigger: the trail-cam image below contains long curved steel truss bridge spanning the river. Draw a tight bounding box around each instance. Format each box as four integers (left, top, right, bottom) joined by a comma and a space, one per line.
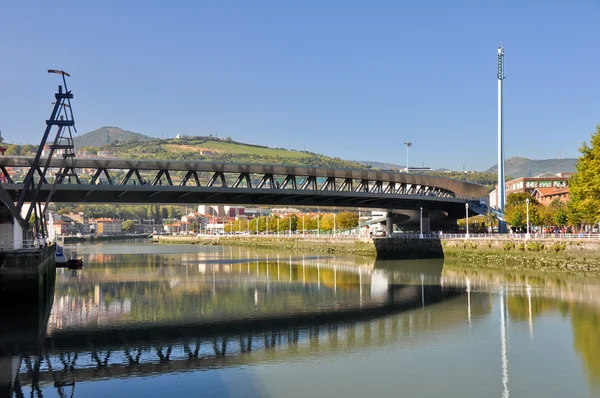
0, 156, 488, 216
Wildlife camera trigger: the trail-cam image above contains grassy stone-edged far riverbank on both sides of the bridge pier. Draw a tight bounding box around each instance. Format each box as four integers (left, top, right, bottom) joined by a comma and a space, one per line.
155, 236, 600, 273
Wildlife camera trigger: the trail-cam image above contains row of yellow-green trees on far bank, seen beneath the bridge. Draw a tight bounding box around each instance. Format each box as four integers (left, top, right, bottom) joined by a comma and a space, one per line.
225, 212, 358, 234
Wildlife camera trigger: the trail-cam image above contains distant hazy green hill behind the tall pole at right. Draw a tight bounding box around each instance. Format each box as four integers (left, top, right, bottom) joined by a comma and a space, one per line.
485, 157, 577, 178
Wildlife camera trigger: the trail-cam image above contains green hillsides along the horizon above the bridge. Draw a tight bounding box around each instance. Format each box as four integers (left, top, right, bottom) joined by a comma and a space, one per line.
6, 126, 576, 189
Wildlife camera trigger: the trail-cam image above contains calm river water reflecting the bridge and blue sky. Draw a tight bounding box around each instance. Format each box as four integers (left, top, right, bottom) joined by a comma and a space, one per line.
0, 242, 600, 398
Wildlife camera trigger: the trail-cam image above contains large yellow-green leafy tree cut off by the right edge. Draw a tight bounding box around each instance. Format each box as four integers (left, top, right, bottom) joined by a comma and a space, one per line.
569, 125, 600, 224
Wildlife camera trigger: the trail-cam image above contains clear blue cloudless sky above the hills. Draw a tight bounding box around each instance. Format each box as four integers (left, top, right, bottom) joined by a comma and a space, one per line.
0, 0, 600, 170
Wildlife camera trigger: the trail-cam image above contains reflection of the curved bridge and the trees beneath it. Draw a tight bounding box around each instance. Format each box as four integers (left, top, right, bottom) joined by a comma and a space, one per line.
3, 257, 490, 396
